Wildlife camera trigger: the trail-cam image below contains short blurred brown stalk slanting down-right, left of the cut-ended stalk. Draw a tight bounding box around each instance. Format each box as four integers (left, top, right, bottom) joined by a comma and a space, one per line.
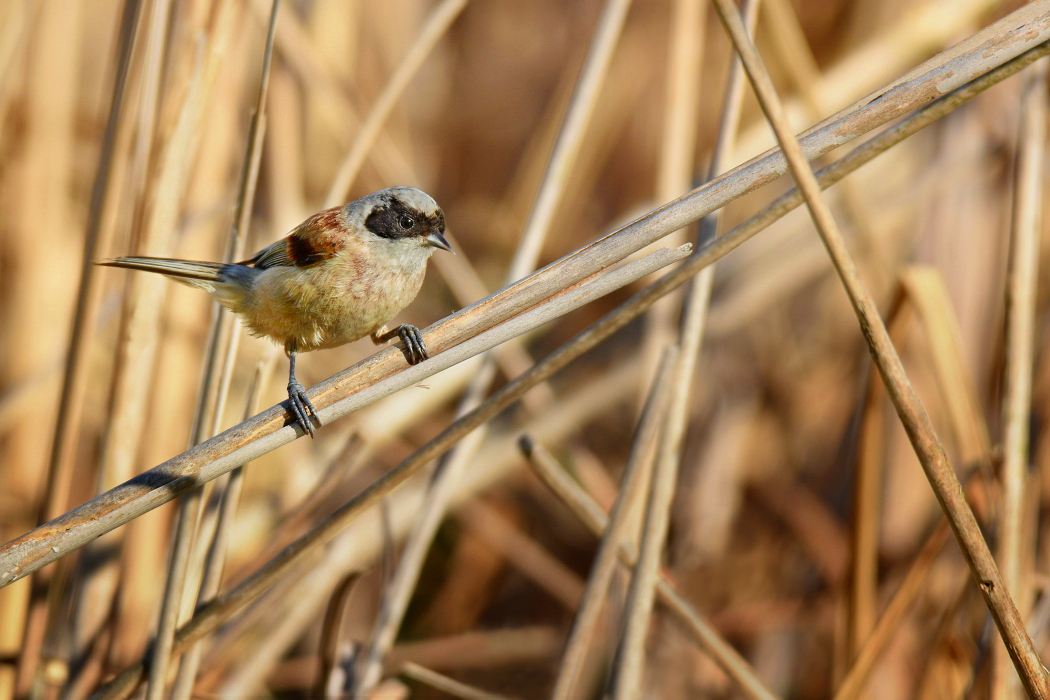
457, 501, 585, 610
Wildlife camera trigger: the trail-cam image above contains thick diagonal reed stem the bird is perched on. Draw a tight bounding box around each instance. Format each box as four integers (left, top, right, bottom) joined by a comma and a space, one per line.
0, 19, 1050, 587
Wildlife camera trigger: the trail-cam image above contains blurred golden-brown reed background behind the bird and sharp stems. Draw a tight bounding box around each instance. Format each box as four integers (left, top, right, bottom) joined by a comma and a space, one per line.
0, 0, 1050, 700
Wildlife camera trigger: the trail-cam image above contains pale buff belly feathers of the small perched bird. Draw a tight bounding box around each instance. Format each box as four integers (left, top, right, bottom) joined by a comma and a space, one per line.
233, 263, 426, 352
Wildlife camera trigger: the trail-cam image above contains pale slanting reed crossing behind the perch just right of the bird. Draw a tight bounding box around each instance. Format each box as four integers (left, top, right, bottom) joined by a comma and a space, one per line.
356, 0, 631, 695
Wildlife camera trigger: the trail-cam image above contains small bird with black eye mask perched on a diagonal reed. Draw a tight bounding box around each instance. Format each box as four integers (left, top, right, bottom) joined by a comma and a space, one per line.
98, 187, 454, 437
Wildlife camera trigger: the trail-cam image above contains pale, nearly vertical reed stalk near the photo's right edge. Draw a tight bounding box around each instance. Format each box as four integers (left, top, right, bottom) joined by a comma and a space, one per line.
990, 60, 1048, 700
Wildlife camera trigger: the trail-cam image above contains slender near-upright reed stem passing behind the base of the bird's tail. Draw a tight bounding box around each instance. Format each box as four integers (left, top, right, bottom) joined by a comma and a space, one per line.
146, 5, 280, 700
